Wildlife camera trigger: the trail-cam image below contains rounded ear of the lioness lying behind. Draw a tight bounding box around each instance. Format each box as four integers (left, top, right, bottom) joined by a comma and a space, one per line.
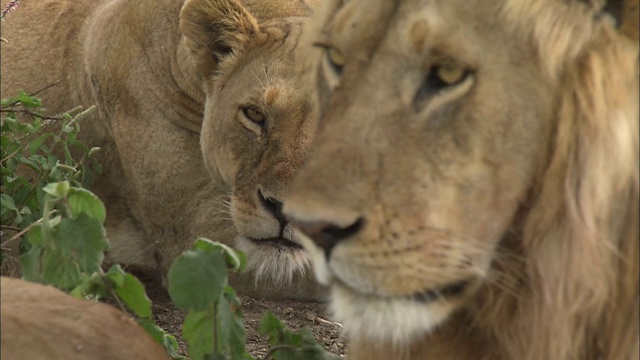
180, 0, 258, 76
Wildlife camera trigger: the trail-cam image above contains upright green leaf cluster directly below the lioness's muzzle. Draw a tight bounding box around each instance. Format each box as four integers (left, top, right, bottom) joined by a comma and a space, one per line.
169, 238, 253, 360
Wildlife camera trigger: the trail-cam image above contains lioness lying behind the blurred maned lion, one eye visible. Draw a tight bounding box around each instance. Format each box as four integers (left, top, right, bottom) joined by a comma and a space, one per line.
2, 0, 326, 300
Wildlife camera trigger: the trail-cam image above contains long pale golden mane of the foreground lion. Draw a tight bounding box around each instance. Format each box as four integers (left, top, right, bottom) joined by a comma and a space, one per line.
458, 1, 640, 360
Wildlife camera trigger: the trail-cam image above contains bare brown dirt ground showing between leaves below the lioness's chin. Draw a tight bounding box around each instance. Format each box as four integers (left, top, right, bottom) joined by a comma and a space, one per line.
135, 274, 345, 359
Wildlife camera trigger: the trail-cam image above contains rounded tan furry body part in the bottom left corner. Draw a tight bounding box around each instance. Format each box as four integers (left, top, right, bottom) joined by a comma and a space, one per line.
0, 277, 167, 360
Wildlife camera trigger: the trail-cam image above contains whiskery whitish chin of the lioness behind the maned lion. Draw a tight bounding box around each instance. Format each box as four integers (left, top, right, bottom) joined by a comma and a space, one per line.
236, 237, 311, 286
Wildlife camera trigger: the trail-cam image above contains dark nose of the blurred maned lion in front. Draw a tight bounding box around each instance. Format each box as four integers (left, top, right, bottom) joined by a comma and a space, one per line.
291, 218, 364, 258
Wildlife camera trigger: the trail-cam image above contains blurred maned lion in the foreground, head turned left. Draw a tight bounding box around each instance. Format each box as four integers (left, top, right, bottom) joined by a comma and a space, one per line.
284, 0, 640, 360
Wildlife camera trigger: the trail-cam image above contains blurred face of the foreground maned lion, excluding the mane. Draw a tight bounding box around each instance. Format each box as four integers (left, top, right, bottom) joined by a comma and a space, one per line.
284, 0, 556, 340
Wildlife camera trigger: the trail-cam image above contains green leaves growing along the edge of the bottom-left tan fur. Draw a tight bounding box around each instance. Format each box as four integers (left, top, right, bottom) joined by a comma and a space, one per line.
20, 181, 183, 359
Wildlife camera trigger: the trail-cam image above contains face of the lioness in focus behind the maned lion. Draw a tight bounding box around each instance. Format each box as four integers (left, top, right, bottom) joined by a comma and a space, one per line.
201, 23, 315, 284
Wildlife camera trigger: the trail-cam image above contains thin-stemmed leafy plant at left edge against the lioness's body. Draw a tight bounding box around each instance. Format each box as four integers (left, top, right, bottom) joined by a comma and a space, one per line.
0, 91, 101, 231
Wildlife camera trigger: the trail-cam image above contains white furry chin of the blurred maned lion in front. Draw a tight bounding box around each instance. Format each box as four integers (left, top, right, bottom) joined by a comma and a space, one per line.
330, 282, 457, 346
